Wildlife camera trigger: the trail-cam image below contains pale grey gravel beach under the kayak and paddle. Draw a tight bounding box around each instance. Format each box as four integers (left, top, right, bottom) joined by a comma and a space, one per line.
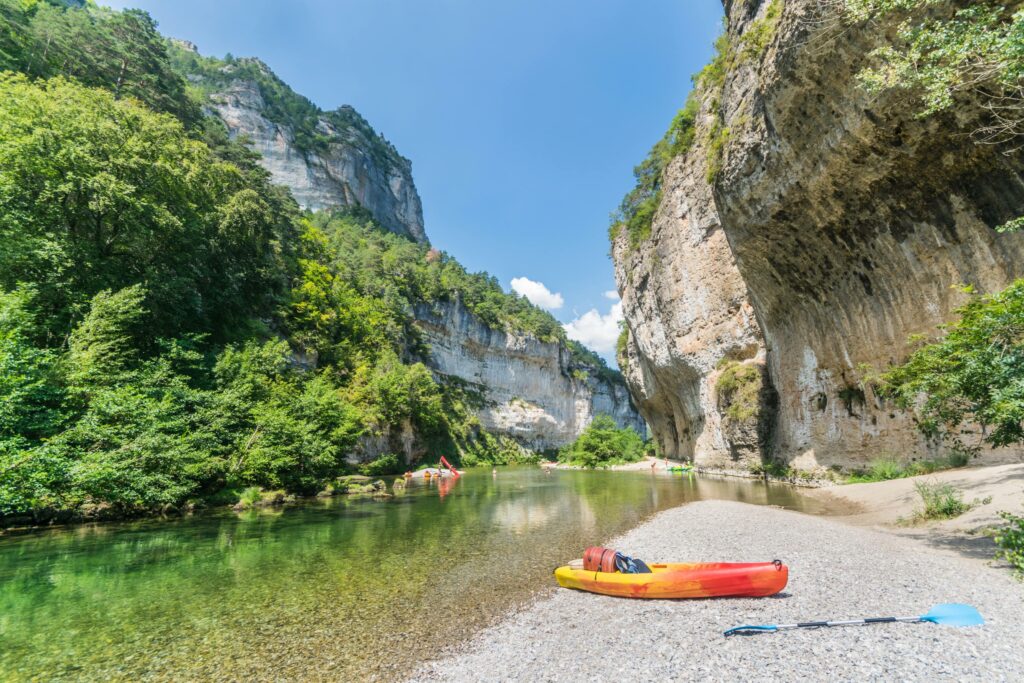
413, 501, 1024, 681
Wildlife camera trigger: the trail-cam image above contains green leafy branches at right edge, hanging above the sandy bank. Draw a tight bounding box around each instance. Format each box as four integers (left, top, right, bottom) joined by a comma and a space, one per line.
884, 281, 1024, 446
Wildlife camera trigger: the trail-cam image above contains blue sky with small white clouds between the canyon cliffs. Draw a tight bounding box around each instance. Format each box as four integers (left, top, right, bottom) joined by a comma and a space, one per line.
101, 0, 722, 357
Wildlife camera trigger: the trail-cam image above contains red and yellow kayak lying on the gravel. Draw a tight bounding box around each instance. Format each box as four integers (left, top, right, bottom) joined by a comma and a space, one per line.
555, 561, 790, 598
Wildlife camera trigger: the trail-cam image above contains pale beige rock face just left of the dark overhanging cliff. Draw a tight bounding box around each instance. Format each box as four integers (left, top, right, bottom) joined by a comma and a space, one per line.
612, 130, 770, 468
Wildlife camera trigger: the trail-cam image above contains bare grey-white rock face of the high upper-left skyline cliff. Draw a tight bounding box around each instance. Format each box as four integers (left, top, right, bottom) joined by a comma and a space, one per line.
210, 80, 427, 243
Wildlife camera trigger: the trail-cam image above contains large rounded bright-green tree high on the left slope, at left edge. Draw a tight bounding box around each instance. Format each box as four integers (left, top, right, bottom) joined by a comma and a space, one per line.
0, 74, 293, 339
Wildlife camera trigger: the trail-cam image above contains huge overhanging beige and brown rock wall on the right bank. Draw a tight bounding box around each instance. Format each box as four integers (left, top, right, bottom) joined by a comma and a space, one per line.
613, 0, 1024, 469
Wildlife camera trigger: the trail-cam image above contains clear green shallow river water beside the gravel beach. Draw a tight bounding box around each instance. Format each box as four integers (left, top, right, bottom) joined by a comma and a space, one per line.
0, 468, 818, 681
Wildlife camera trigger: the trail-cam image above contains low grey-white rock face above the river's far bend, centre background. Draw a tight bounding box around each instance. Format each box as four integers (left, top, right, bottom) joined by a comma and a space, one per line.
415, 303, 646, 451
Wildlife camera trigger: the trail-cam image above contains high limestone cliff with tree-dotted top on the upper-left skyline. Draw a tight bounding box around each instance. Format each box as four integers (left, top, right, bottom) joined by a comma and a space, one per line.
173, 41, 427, 243
